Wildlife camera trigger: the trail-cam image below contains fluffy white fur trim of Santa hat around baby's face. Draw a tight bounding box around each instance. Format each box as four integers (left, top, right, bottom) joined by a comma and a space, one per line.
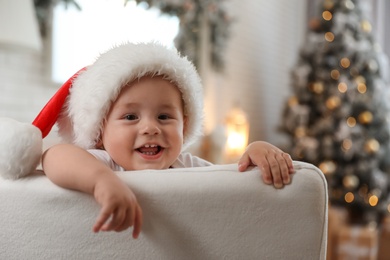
58, 43, 203, 149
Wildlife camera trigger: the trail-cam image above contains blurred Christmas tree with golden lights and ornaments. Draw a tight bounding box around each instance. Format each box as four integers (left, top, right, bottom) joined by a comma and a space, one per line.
282, 0, 390, 223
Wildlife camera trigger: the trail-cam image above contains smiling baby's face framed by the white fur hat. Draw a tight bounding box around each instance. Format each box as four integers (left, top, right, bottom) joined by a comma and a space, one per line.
101, 77, 184, 170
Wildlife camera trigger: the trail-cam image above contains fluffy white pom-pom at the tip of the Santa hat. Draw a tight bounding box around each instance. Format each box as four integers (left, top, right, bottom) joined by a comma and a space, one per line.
0, 118, 42, 179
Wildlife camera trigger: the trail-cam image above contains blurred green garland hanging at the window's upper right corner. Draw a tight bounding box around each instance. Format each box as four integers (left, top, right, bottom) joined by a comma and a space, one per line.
125, 0, 231, 71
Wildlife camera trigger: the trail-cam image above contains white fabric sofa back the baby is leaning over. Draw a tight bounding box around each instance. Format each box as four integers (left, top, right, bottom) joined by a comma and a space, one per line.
0, 162, 328, 260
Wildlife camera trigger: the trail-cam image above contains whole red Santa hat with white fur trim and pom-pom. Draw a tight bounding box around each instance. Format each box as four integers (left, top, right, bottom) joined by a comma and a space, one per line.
0, 43, 203, 179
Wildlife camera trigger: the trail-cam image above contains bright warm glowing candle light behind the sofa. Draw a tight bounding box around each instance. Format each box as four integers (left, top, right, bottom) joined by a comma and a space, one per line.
225, 107, 249, 162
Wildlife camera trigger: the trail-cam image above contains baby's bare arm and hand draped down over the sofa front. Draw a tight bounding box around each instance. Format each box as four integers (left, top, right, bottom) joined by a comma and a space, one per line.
42, 144, 142, 238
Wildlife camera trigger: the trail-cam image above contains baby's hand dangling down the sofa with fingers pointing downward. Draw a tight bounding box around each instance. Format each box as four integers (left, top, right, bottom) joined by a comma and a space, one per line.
93, 175, 142, 238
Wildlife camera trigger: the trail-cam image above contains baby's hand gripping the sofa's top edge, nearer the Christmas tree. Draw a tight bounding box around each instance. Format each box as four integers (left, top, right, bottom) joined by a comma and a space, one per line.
238, 141, 294, 189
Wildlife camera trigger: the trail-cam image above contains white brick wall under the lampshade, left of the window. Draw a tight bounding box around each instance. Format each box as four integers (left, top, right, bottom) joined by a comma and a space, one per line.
0, 44, 57, 149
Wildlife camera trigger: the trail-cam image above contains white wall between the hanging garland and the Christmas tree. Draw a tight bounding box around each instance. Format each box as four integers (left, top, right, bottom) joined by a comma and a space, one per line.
205, 0, 307, 145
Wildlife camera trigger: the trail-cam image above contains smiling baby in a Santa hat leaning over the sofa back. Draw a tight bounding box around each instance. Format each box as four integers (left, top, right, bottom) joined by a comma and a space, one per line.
34, 43, 293, 238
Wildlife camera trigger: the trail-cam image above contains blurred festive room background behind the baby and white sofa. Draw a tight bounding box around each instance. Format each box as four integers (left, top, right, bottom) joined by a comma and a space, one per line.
0, 0, 390, 259
